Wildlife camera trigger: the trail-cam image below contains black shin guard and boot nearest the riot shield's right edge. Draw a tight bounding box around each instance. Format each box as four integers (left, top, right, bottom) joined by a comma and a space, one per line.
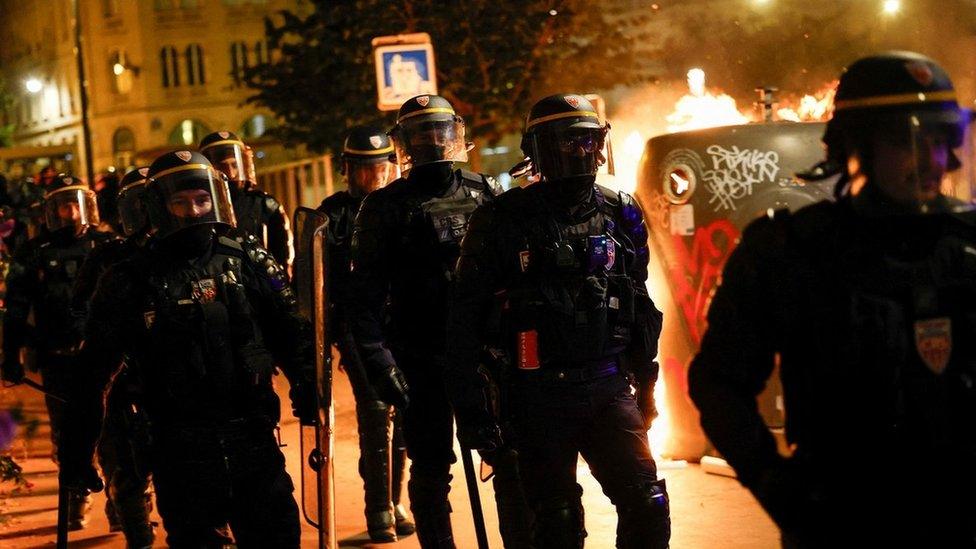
356, 401, 397, 543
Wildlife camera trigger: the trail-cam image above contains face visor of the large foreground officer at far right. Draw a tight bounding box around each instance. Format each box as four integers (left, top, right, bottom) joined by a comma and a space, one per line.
848, 112, 974, 213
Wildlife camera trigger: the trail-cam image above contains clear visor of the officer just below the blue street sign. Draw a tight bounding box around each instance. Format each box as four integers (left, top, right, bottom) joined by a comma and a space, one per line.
390, 116, 468, 172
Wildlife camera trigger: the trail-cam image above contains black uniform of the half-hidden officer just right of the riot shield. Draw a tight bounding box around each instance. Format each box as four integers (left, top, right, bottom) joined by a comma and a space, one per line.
318, 191, 407, 536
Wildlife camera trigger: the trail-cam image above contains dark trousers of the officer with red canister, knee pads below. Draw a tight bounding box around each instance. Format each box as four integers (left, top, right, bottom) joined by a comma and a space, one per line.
512, 371, 670, 547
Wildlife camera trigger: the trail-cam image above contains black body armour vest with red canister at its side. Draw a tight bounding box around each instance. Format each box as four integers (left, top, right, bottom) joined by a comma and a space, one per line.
502, 185, 635, 369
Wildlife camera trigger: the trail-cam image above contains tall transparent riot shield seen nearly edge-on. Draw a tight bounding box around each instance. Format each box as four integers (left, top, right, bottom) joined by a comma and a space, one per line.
294, 208, 337, 549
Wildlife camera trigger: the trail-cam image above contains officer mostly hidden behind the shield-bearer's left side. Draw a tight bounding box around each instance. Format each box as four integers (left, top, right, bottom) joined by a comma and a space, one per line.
72, 166, 155, 547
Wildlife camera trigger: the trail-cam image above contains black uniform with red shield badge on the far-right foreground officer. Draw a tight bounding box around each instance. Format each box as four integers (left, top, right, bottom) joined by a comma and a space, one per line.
689, 193, 976, 547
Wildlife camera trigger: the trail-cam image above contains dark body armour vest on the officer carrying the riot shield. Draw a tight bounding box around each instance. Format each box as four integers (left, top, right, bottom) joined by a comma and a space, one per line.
136, 237, 278, 421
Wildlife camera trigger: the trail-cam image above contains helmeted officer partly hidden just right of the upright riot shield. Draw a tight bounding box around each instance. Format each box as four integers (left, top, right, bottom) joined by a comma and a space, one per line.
318, 126, 414, 542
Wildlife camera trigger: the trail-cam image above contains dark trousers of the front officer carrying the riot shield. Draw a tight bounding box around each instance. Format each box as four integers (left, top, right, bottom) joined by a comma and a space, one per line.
154, 423, 301, 549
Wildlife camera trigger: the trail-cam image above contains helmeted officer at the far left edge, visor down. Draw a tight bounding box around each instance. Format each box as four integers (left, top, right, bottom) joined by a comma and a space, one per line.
2, 174, 113, 530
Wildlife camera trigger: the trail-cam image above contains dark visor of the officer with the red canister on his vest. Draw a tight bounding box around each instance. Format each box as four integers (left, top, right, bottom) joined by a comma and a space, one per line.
531, 124, 610, 181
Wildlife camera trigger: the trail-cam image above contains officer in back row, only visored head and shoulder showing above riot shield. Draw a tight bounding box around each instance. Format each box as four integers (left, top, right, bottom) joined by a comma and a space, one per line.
200, 131, 292, 268
